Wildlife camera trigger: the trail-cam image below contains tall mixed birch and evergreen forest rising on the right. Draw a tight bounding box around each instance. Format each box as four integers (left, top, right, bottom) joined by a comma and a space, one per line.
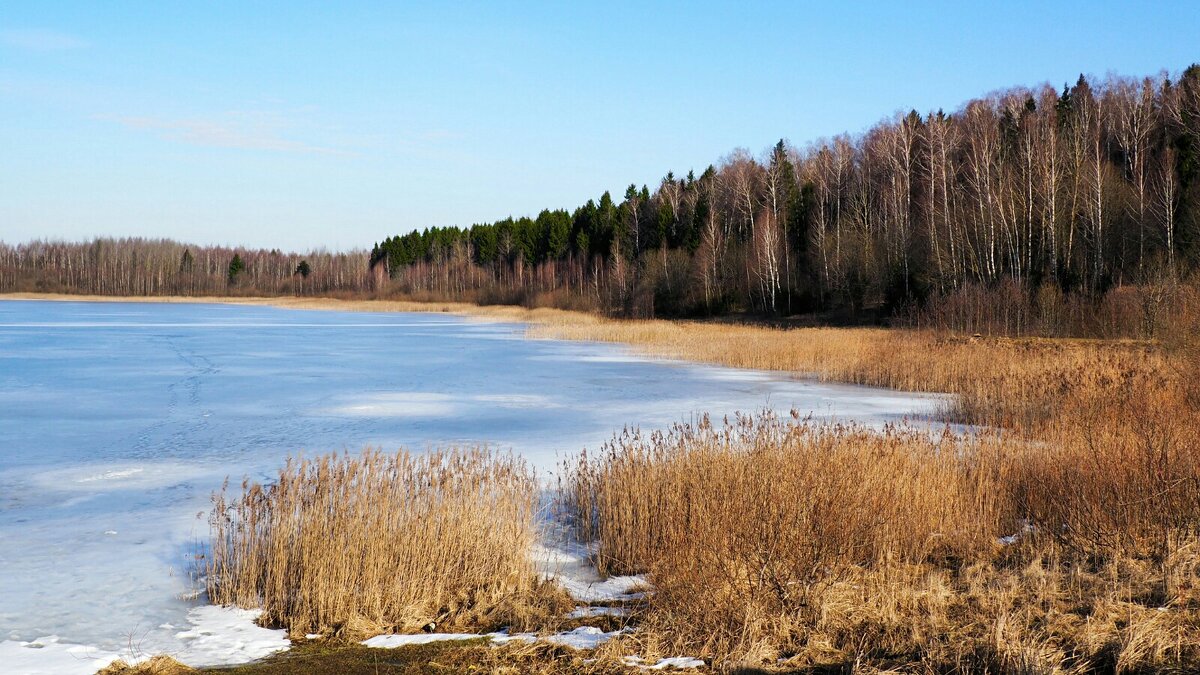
370, 65, 1200, 331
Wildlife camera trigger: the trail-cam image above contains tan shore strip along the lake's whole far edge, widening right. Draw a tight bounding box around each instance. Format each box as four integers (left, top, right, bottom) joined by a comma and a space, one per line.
0, 293, 1162, 426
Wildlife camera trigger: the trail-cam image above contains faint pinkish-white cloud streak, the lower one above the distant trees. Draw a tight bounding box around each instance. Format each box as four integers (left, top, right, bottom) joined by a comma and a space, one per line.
112, 117, 344, 155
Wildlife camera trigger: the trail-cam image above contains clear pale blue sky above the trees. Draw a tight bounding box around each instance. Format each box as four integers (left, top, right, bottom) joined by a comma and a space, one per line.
0, 1, 1200, 249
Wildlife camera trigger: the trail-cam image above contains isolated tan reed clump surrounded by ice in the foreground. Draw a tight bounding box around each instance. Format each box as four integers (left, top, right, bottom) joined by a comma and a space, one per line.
208, 448, 562, 638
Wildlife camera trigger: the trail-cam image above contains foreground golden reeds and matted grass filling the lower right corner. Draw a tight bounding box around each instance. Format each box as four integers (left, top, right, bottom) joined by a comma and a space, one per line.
560, 408, 1200, 673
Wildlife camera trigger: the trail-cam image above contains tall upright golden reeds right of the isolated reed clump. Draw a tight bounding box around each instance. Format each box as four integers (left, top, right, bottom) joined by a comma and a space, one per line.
562, 412, 1012, 576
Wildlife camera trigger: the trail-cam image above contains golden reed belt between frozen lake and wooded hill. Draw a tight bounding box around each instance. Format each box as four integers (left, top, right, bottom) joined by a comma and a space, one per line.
534, 315, 1171, 426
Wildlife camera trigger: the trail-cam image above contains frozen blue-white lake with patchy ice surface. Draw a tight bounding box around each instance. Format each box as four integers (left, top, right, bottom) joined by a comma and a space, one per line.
0, 300, 938, 670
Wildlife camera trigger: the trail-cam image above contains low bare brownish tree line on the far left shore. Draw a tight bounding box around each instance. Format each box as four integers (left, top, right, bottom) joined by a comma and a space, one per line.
0, 239, 377, 295
